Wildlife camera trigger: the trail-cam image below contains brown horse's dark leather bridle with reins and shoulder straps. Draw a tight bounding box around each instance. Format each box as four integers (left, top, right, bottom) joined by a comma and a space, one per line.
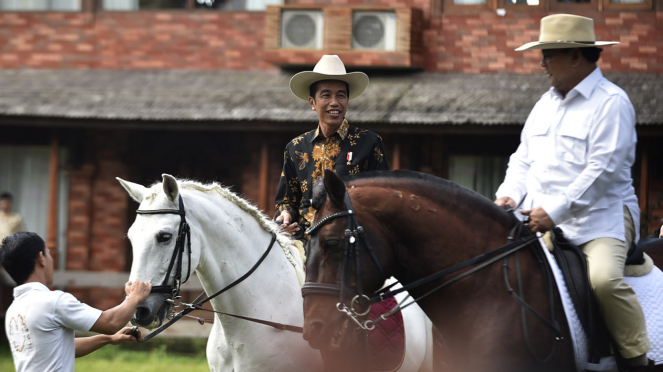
302, 190, 563, 362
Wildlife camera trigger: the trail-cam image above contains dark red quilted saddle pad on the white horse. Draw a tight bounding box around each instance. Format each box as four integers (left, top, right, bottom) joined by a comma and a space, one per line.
368, 297, 405, 372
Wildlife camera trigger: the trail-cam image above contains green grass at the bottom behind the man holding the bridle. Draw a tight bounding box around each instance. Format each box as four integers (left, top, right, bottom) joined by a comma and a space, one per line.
0, 339, 209, 372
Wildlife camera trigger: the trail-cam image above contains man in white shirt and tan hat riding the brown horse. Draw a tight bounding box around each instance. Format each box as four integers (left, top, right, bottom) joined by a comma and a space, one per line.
495, 14, 653, 371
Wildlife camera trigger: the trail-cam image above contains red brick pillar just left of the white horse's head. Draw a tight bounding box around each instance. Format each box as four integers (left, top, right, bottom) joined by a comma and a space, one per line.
66, 131, 128, 310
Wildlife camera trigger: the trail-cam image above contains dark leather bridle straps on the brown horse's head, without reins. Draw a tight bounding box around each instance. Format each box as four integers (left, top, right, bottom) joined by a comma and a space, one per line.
302, 190, 386, 322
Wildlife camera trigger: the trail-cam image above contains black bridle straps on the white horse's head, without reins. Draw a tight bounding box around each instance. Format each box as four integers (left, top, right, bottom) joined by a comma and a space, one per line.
136, 195, 191, 300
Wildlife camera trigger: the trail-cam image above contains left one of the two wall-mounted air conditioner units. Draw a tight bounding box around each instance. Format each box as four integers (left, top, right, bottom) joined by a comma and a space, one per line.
281, 9, 324, 49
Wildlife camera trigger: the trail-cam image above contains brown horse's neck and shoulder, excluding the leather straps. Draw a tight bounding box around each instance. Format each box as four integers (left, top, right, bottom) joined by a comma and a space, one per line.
348, 173, 573, 372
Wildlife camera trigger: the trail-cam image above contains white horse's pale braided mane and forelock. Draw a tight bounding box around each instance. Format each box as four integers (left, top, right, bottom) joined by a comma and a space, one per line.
151, 178, 306, 284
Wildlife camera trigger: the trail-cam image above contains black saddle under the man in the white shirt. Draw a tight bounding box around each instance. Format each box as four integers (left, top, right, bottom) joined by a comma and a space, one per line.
551, 228, 663, 358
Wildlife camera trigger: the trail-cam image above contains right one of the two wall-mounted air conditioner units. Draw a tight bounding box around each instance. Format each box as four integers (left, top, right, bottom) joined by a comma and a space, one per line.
352, 11, 396, 51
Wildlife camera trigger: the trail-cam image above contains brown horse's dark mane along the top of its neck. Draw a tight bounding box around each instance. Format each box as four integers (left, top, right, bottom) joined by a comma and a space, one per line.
343, 170, 512, 224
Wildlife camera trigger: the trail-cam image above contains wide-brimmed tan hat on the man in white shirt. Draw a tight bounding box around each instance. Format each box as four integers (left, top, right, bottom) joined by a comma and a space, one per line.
516, 14, 619, 51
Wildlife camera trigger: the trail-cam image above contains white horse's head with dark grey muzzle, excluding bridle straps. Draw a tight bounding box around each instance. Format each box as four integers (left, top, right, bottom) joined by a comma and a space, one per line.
118, 174, 200, 329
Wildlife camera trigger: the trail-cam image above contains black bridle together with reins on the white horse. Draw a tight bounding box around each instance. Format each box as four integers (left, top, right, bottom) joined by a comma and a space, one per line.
136, 195, 303, 342
